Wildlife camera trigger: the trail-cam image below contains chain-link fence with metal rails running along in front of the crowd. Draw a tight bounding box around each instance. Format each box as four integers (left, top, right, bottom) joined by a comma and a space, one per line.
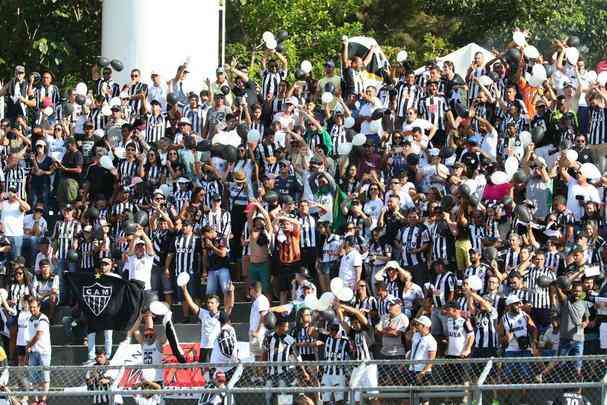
0, 356, 607, 405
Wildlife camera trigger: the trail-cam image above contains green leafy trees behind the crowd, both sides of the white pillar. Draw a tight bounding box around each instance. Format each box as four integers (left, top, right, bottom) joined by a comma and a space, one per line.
0, 0, 607, 86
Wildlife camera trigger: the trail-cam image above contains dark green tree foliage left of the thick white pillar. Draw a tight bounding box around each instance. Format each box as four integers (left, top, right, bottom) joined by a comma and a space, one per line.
0, 0, 101, 85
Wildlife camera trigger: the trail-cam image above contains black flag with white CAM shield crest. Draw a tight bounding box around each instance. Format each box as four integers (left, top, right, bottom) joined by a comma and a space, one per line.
64, 272, 143, 331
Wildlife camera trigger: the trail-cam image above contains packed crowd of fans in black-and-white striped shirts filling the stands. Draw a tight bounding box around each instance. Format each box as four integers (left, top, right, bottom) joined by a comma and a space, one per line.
0, 29, 607, 403
